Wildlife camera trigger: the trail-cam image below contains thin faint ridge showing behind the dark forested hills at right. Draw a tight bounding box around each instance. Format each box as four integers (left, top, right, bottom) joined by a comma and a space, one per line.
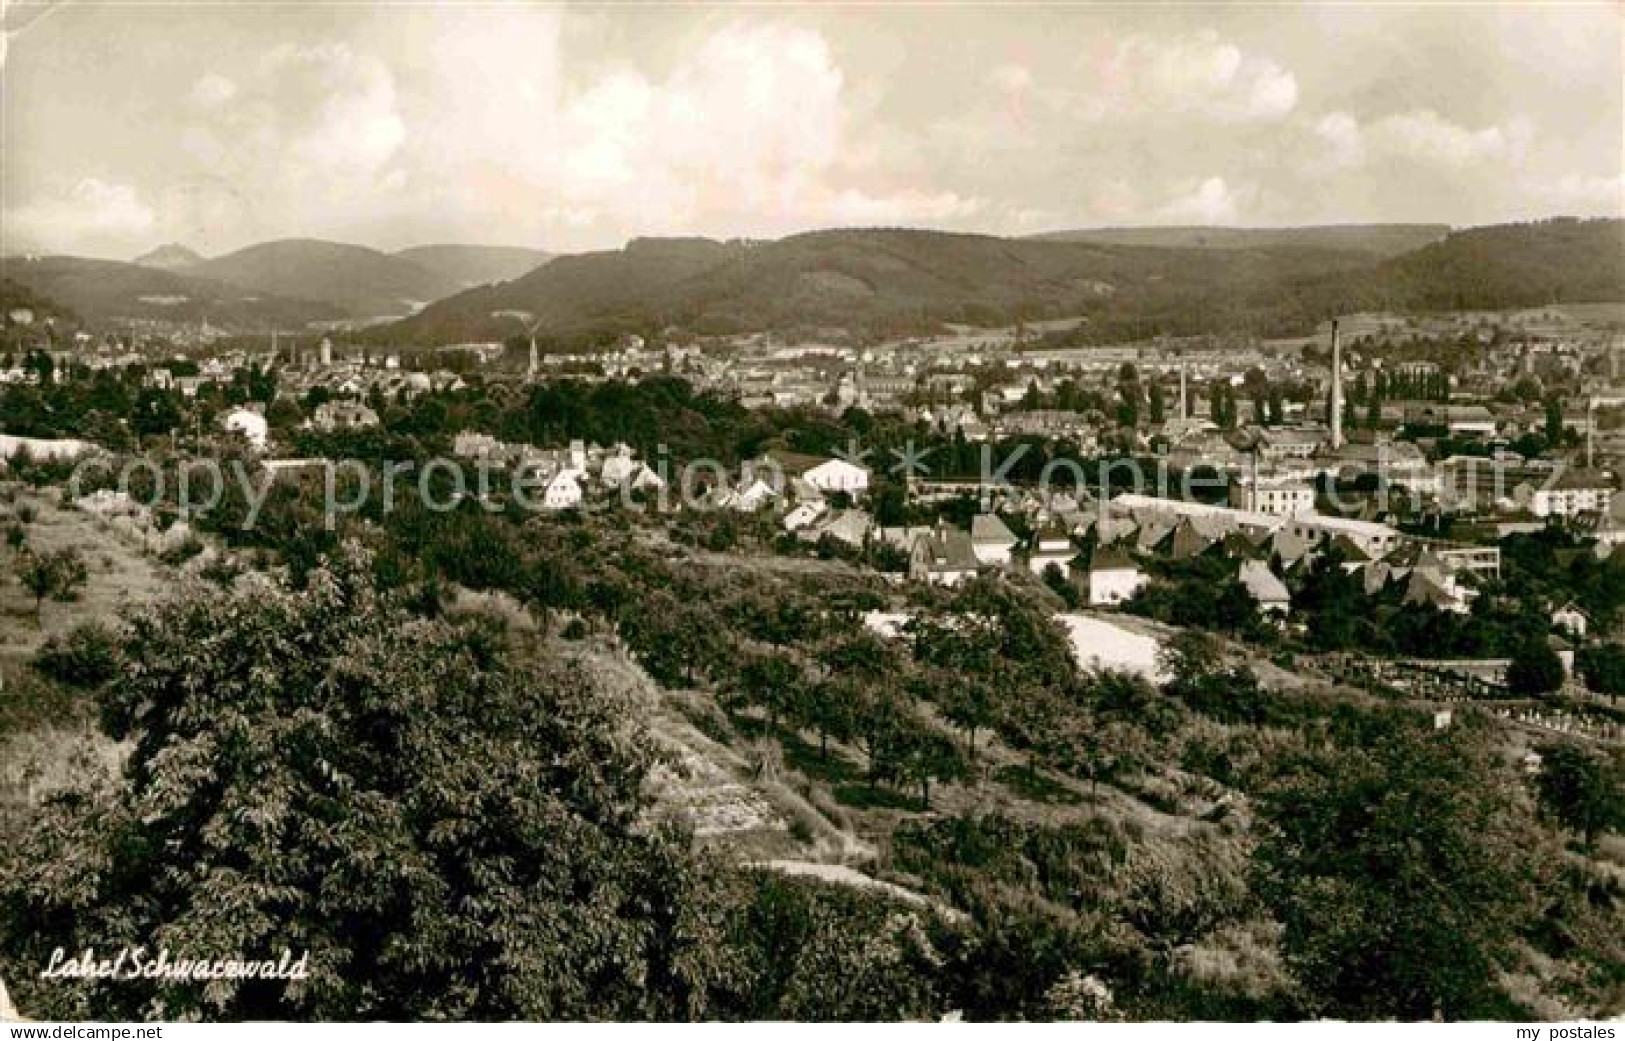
1032, 224, 1450, 257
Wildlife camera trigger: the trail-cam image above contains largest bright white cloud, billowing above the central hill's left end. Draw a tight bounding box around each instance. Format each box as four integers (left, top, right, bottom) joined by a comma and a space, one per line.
487, 23, 980, 234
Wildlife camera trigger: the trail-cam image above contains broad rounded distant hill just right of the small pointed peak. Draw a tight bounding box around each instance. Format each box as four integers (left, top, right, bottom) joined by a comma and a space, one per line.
187, 239, 463, 318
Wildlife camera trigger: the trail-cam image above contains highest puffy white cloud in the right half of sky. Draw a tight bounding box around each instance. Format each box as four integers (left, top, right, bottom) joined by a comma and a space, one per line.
1092, 31, 1298, 122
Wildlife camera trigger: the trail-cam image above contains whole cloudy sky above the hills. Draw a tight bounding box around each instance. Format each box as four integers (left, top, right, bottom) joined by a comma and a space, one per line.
0, 0, 1625, 257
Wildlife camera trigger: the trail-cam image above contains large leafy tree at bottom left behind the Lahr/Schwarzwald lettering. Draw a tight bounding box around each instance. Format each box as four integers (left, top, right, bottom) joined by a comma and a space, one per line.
0, 555, 748, 1020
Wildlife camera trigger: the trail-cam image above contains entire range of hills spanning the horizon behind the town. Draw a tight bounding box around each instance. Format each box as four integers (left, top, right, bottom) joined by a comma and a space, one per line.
0, 218, 1625, 346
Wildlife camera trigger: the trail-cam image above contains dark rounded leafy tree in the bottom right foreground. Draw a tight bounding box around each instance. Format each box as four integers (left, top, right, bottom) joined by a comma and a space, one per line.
1256, 718, 1550, 1020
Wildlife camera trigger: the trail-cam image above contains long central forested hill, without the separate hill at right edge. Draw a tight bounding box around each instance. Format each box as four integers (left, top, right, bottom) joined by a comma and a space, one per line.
385, 229, 1367, 343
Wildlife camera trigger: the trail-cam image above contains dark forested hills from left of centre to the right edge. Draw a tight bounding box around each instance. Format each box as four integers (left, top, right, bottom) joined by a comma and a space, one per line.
380, 219, 1625, 346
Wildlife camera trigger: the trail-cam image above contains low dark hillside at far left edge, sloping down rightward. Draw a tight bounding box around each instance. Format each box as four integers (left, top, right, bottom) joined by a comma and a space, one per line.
5, 257, 343, 330
